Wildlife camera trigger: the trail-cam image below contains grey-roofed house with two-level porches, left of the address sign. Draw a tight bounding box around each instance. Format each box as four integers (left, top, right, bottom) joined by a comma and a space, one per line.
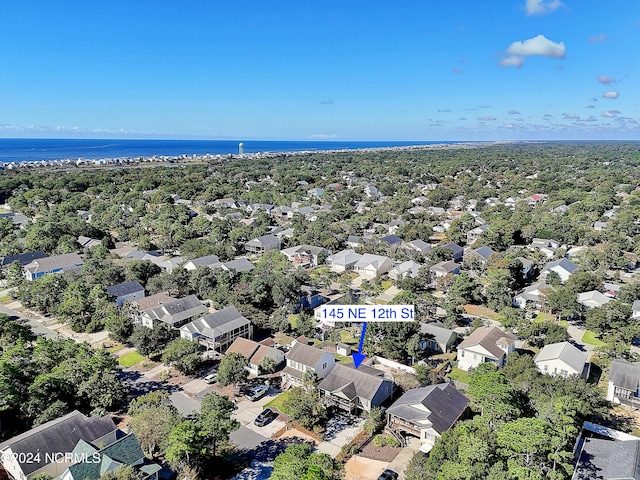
180, 306, 253, 353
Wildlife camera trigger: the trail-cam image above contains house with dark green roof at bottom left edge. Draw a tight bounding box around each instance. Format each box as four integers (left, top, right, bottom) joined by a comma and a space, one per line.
59, 430, 162, 480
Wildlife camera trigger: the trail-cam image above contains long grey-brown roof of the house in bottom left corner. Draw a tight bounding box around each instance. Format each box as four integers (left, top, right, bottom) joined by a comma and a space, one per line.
0, 410, 116, 476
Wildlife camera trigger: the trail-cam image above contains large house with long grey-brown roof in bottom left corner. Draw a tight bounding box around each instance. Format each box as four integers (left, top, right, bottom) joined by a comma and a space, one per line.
0, 410, 116, 480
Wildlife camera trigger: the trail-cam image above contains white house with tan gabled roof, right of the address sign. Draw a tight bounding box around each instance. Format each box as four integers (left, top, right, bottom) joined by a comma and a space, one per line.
458, 327, 516, 372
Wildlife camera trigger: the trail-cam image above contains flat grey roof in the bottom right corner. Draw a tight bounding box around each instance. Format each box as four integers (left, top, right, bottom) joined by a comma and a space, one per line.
572, 438, 640, 480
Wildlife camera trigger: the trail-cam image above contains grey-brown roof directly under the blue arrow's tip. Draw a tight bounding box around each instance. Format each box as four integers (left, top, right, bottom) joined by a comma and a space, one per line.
318, 363, 391, 400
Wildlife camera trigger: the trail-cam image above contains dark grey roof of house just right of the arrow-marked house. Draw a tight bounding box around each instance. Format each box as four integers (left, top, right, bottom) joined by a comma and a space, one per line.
387, 383, 469, 433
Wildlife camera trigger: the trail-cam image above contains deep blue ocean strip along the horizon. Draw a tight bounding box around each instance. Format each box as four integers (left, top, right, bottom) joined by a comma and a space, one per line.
0, 138, 459, 162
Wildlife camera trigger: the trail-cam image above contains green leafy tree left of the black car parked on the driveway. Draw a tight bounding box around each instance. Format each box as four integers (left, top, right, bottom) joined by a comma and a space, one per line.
198, 392, 240, 457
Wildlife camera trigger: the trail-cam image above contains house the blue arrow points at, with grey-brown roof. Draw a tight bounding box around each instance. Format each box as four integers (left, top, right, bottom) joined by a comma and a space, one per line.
318, 363, 393, 413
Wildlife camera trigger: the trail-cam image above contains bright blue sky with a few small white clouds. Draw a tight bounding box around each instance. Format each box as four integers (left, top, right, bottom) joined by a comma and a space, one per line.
0, 0, 640, 140
